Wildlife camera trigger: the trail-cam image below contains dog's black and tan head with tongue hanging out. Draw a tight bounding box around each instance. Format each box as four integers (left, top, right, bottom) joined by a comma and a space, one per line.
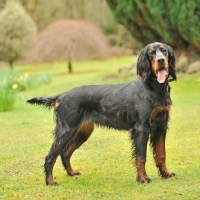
137, 42, 176, 83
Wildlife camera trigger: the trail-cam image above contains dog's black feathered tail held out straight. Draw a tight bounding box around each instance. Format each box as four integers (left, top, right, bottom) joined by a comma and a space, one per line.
27, 95, 60, 108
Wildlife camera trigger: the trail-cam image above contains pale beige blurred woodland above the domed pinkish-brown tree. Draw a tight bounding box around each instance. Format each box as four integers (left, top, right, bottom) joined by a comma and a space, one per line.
19, 0, 116, 30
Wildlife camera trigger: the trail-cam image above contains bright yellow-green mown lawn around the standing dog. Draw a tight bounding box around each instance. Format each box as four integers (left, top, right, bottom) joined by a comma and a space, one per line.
0, 57, 200, 200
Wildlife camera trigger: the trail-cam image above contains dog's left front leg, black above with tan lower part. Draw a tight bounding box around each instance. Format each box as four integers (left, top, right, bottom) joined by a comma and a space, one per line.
130, 128, 151, 183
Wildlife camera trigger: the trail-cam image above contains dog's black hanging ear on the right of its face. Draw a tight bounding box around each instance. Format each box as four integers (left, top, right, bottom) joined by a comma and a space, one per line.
167, 46, 177, 80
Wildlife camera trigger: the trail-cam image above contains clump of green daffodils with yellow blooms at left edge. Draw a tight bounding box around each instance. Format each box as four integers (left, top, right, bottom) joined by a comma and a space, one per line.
0, 71, 51, 112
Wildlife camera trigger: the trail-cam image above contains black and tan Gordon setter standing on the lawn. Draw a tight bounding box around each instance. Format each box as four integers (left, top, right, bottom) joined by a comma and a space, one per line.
27, 42, 176, 185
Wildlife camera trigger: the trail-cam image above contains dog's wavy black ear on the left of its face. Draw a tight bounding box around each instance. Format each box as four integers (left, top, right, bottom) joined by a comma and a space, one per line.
137, 45, 151, 80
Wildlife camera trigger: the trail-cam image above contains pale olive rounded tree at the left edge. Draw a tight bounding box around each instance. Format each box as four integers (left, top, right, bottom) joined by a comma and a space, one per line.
0, 1, 37, 68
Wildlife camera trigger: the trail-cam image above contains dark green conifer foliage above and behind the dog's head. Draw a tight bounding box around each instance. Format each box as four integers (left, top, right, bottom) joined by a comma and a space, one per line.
107, 0, 200, 50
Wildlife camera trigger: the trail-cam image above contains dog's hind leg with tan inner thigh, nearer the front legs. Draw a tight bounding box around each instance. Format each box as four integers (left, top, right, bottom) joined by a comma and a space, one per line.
60, 122, 94, 176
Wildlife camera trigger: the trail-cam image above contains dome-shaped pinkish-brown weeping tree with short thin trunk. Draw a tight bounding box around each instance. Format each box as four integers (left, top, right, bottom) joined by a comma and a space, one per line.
25, 20, 118, 73
